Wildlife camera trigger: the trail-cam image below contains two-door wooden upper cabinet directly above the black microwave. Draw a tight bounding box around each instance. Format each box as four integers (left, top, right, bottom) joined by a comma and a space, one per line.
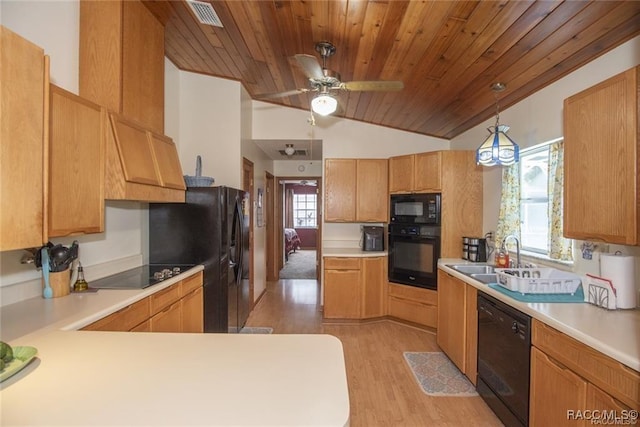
389, 151, 443, 193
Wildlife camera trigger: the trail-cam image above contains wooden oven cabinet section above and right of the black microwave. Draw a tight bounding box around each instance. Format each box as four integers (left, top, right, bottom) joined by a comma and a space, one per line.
389, 151, 482, 258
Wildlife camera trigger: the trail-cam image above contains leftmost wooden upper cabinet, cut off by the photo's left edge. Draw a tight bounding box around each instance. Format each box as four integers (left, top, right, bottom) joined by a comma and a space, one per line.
0, 26, 49, 251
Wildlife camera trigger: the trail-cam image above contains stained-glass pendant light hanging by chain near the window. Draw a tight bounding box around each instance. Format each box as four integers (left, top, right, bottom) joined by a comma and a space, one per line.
476, 83, 520, 166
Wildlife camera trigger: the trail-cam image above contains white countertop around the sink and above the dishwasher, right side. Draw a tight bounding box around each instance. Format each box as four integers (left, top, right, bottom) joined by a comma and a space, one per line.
438, 258, 640, 371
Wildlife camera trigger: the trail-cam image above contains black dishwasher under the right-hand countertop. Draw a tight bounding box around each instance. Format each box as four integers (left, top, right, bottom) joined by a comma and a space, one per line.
477, 293, 531, 427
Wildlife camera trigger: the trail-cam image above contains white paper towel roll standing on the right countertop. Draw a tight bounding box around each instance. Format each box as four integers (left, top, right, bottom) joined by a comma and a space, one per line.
600, 254, 636, 308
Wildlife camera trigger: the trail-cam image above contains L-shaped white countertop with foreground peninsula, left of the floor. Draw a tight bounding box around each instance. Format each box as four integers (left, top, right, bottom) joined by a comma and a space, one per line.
0, 266, 349, 426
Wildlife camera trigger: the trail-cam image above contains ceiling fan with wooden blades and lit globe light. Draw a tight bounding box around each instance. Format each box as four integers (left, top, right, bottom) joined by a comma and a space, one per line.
258, 41, 404, 116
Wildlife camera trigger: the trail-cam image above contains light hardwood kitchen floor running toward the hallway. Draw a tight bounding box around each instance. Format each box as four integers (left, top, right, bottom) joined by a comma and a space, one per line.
247, 280, 502, 427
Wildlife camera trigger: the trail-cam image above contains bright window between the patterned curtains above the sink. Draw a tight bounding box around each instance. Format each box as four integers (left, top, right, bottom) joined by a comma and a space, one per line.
520, 145, 549, 255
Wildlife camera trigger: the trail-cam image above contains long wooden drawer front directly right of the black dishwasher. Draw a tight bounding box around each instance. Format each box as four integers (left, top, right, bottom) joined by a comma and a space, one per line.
532, 320, 640, 408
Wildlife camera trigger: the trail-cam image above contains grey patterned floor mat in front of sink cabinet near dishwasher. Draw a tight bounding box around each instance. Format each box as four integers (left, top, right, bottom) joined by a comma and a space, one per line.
404, 351, 478, 397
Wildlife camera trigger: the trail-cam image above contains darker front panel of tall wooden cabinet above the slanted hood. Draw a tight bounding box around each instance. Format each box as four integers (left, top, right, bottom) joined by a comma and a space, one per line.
122, 0, 164, 134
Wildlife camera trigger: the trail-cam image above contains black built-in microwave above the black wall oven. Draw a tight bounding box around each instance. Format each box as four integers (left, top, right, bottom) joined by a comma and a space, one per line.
389, 193, 440, 225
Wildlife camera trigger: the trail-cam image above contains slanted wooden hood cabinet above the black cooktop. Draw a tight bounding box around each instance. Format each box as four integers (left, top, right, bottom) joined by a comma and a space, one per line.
105, 113, 186, 202
